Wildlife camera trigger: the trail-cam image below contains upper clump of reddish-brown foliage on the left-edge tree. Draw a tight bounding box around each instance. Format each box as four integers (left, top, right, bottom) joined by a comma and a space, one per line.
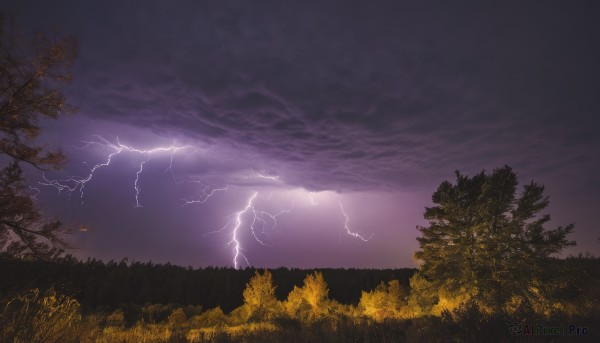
0, 16, 77, 168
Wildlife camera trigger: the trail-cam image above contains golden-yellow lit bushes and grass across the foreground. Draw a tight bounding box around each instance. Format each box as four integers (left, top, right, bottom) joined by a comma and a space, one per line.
0, 257, 600, 343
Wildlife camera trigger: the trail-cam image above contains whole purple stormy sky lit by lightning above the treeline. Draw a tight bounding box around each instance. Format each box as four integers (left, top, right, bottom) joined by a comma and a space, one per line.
0, 0, 600, 268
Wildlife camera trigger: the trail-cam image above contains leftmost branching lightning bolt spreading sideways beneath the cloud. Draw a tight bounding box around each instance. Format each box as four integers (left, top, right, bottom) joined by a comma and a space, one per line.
39, 136, 187, 207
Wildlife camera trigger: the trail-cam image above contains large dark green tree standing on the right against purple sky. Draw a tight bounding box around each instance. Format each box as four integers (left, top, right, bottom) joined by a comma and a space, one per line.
415, 166, 575, 312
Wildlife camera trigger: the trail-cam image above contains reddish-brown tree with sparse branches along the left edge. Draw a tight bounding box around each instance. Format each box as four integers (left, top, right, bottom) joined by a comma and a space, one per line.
0, 15, 76, 257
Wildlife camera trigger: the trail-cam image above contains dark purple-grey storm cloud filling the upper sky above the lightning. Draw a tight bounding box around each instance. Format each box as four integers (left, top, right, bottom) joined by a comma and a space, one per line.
4, 1, 600, 268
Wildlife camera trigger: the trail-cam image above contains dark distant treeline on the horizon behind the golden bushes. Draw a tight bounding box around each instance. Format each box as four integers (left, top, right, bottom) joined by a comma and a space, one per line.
0, 256, 416, 312
